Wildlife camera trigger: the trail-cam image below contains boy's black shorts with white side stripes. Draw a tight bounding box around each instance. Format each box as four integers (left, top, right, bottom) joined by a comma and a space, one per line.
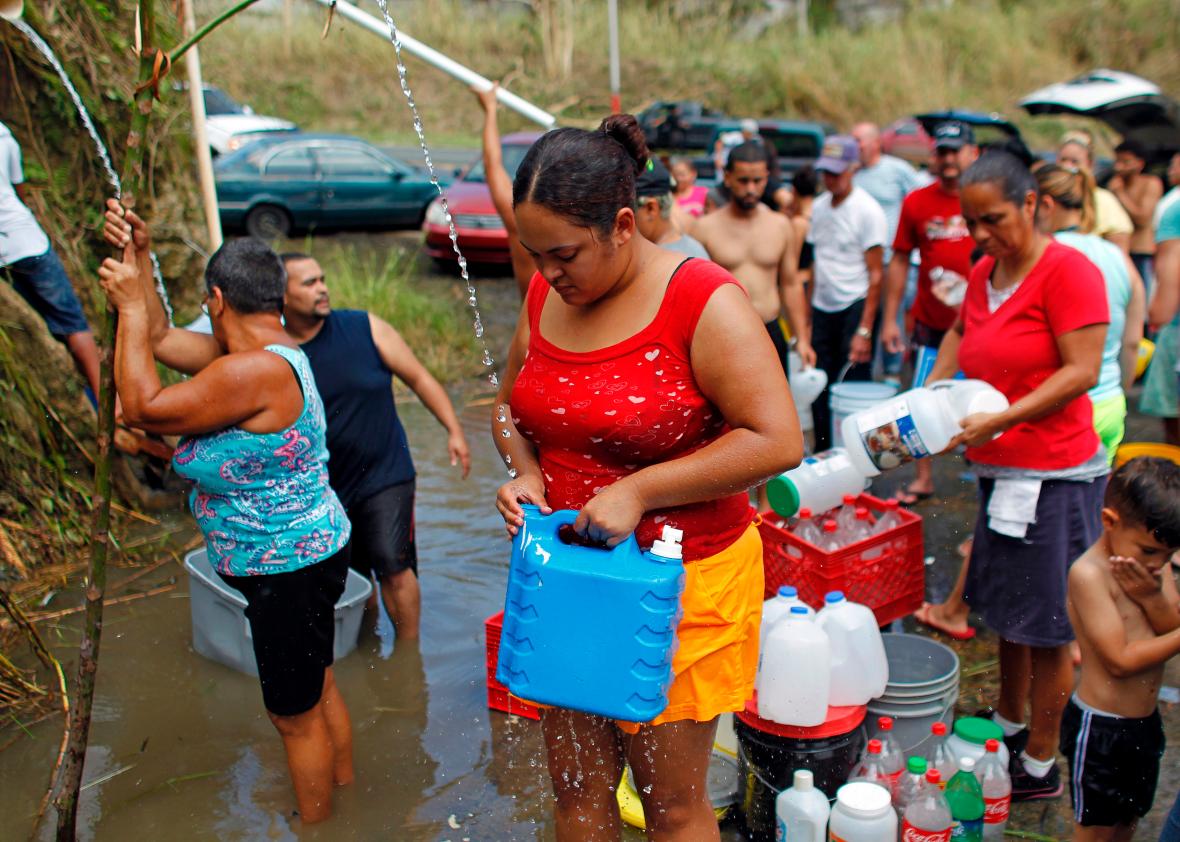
1061, 698, 1165, 828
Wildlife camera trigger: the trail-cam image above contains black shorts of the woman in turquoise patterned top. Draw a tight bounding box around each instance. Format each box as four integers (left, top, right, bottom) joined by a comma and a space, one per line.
218, 546, 348, 716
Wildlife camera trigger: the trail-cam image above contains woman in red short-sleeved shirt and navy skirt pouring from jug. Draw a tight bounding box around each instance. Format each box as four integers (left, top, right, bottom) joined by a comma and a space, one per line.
930, 152, 1109, 801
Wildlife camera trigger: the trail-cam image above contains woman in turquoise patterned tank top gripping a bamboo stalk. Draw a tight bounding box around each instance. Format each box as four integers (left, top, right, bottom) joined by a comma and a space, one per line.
99, 226, 353, 822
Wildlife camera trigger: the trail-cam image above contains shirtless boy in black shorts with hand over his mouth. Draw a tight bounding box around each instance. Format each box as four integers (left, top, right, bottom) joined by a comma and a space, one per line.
1061, 458, 1180, 842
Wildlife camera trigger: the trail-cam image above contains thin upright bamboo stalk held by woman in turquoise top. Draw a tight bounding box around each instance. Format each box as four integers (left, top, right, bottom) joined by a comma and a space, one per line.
52, 0, 166, 825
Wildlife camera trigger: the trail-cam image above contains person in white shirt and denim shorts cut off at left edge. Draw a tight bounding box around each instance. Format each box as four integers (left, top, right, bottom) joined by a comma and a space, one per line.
0, 123, 98, 396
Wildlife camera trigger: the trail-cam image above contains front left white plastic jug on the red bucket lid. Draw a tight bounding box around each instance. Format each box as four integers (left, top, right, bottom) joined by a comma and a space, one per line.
755, 605, 832, 728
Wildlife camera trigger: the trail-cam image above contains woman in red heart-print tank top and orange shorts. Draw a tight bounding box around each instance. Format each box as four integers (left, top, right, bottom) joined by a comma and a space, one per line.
492, 116, 802, 840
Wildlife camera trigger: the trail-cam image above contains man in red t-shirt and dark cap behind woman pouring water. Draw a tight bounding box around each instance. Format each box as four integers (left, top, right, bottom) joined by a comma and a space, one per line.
881, 120, 979, 506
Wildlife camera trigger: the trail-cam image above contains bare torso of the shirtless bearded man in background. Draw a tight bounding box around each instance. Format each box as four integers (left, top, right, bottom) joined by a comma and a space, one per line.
693, 204, 795, 322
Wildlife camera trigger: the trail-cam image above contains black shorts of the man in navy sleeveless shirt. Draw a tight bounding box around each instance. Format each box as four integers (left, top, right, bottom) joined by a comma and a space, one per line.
348, 480, 418, 579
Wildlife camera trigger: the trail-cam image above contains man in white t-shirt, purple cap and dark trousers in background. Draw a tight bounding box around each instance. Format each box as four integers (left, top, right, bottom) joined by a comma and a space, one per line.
807, 134, 887, 450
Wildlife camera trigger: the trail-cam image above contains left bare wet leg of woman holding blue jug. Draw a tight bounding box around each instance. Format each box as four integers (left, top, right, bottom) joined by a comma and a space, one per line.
540, 709, 623, 842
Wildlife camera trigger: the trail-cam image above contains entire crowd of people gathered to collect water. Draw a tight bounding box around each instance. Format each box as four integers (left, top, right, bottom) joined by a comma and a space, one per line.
0, 92, 1180, 840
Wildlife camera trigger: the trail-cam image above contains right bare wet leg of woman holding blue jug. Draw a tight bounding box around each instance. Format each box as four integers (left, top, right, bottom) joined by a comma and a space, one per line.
628, 719, 721, 842
